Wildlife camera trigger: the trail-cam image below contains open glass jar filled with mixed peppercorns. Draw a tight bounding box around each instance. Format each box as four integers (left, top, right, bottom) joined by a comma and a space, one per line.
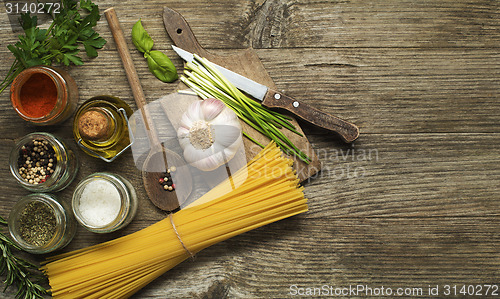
9, 132, 79, 192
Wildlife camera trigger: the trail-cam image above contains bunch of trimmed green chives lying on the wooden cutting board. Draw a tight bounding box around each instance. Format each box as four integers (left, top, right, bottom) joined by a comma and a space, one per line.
181, 55, 311, 164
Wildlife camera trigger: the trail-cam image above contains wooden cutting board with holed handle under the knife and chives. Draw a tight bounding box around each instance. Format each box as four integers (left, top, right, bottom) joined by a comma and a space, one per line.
163, 7, 321, 181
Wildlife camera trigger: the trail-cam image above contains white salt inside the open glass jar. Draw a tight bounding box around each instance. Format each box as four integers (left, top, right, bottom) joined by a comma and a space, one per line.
78, 179, 121, 227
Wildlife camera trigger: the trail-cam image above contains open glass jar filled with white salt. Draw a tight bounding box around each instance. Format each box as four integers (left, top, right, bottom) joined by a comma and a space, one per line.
72, 172, 137, 233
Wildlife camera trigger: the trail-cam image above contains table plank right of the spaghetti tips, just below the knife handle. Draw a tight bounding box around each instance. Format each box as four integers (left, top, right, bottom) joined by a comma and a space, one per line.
305, 134, 500, 218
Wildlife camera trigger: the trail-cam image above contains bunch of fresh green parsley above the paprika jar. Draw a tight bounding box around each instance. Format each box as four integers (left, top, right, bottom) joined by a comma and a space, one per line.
0, 0, 106, 93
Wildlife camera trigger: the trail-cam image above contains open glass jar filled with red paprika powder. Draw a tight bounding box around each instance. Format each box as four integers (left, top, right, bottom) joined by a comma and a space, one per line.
10, 65, 78, 126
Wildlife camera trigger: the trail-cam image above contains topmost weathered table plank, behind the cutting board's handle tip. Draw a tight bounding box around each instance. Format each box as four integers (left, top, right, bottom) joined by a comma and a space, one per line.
15, 0, 492, 49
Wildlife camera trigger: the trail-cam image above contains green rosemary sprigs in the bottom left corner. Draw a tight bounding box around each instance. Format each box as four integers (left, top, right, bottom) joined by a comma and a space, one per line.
0, 216, 47, 299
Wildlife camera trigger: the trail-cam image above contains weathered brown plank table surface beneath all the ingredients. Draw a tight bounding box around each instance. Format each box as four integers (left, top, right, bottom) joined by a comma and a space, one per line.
0, 0, 500, 298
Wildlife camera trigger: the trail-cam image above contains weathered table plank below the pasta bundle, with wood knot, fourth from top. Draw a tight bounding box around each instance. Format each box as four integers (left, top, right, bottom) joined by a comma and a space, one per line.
129, 216, 500, 298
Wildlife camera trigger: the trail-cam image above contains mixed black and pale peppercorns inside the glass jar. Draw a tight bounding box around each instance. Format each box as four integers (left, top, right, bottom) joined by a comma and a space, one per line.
17, 140, 57, 185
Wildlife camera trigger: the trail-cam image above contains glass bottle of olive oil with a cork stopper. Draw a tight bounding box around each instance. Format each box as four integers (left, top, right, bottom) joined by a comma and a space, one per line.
73, 95, 133, 162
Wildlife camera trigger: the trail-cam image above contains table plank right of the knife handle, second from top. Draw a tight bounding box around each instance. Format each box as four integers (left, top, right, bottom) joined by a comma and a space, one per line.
259, 48, 500, 133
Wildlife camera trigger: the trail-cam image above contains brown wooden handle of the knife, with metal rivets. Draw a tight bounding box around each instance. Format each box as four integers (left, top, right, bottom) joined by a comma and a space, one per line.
262, 89, 359, 142
